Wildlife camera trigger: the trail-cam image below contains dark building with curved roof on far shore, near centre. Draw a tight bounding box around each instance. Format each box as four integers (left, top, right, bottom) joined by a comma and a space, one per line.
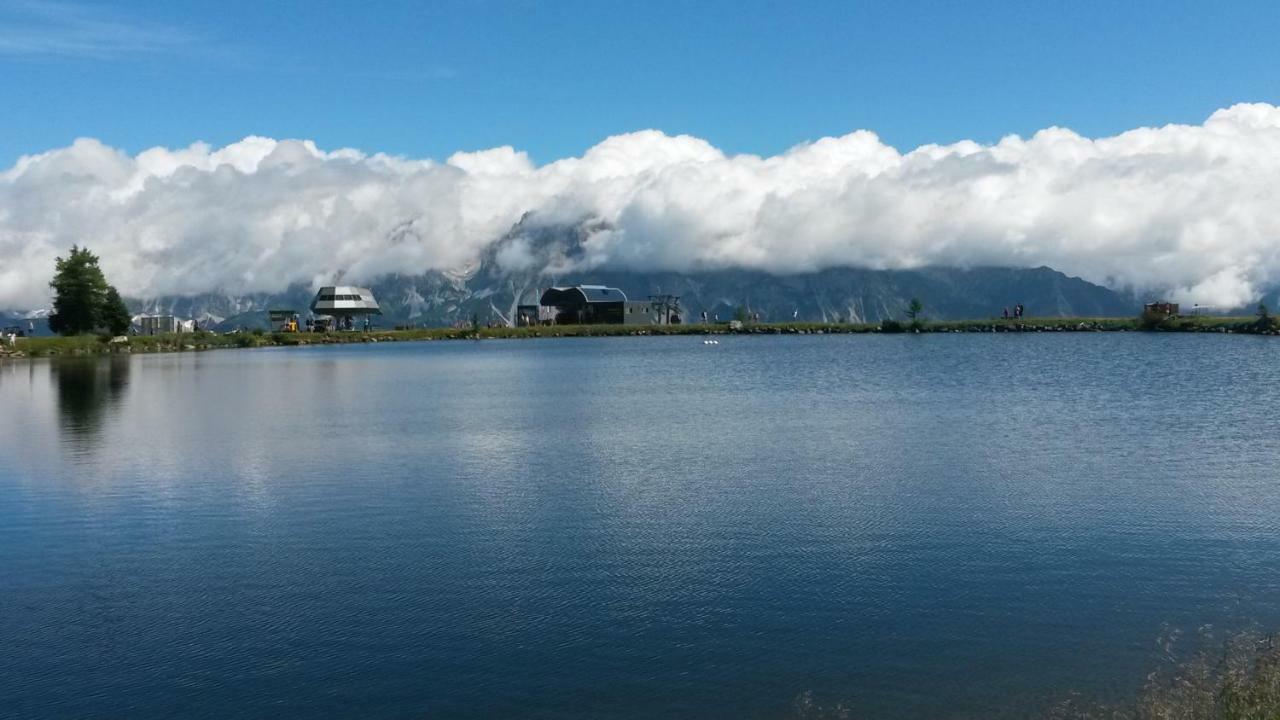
527, 284, 680, 325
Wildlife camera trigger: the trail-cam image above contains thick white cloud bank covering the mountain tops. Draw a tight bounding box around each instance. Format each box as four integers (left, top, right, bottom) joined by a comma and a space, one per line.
0, 104, 1280, 309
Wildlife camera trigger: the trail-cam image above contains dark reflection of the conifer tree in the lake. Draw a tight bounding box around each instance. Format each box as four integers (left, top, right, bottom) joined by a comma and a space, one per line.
49, 357, 129, 441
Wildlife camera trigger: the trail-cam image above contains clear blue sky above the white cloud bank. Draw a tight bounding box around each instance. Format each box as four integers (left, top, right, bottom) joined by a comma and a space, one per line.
0, 0, 1280, 167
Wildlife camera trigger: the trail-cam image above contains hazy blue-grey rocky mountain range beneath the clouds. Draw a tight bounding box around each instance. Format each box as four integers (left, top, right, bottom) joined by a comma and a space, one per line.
0, 219, 1140, 331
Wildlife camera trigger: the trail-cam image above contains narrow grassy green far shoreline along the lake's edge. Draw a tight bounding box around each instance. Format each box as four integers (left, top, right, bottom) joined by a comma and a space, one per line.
0, 316, 1280, 359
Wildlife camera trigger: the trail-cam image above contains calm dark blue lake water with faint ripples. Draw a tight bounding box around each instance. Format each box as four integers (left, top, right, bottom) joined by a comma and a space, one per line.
0, 333, 1280, 719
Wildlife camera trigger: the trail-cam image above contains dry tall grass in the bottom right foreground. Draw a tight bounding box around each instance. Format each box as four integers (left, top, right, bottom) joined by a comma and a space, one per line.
790, 632, 1280, 720
